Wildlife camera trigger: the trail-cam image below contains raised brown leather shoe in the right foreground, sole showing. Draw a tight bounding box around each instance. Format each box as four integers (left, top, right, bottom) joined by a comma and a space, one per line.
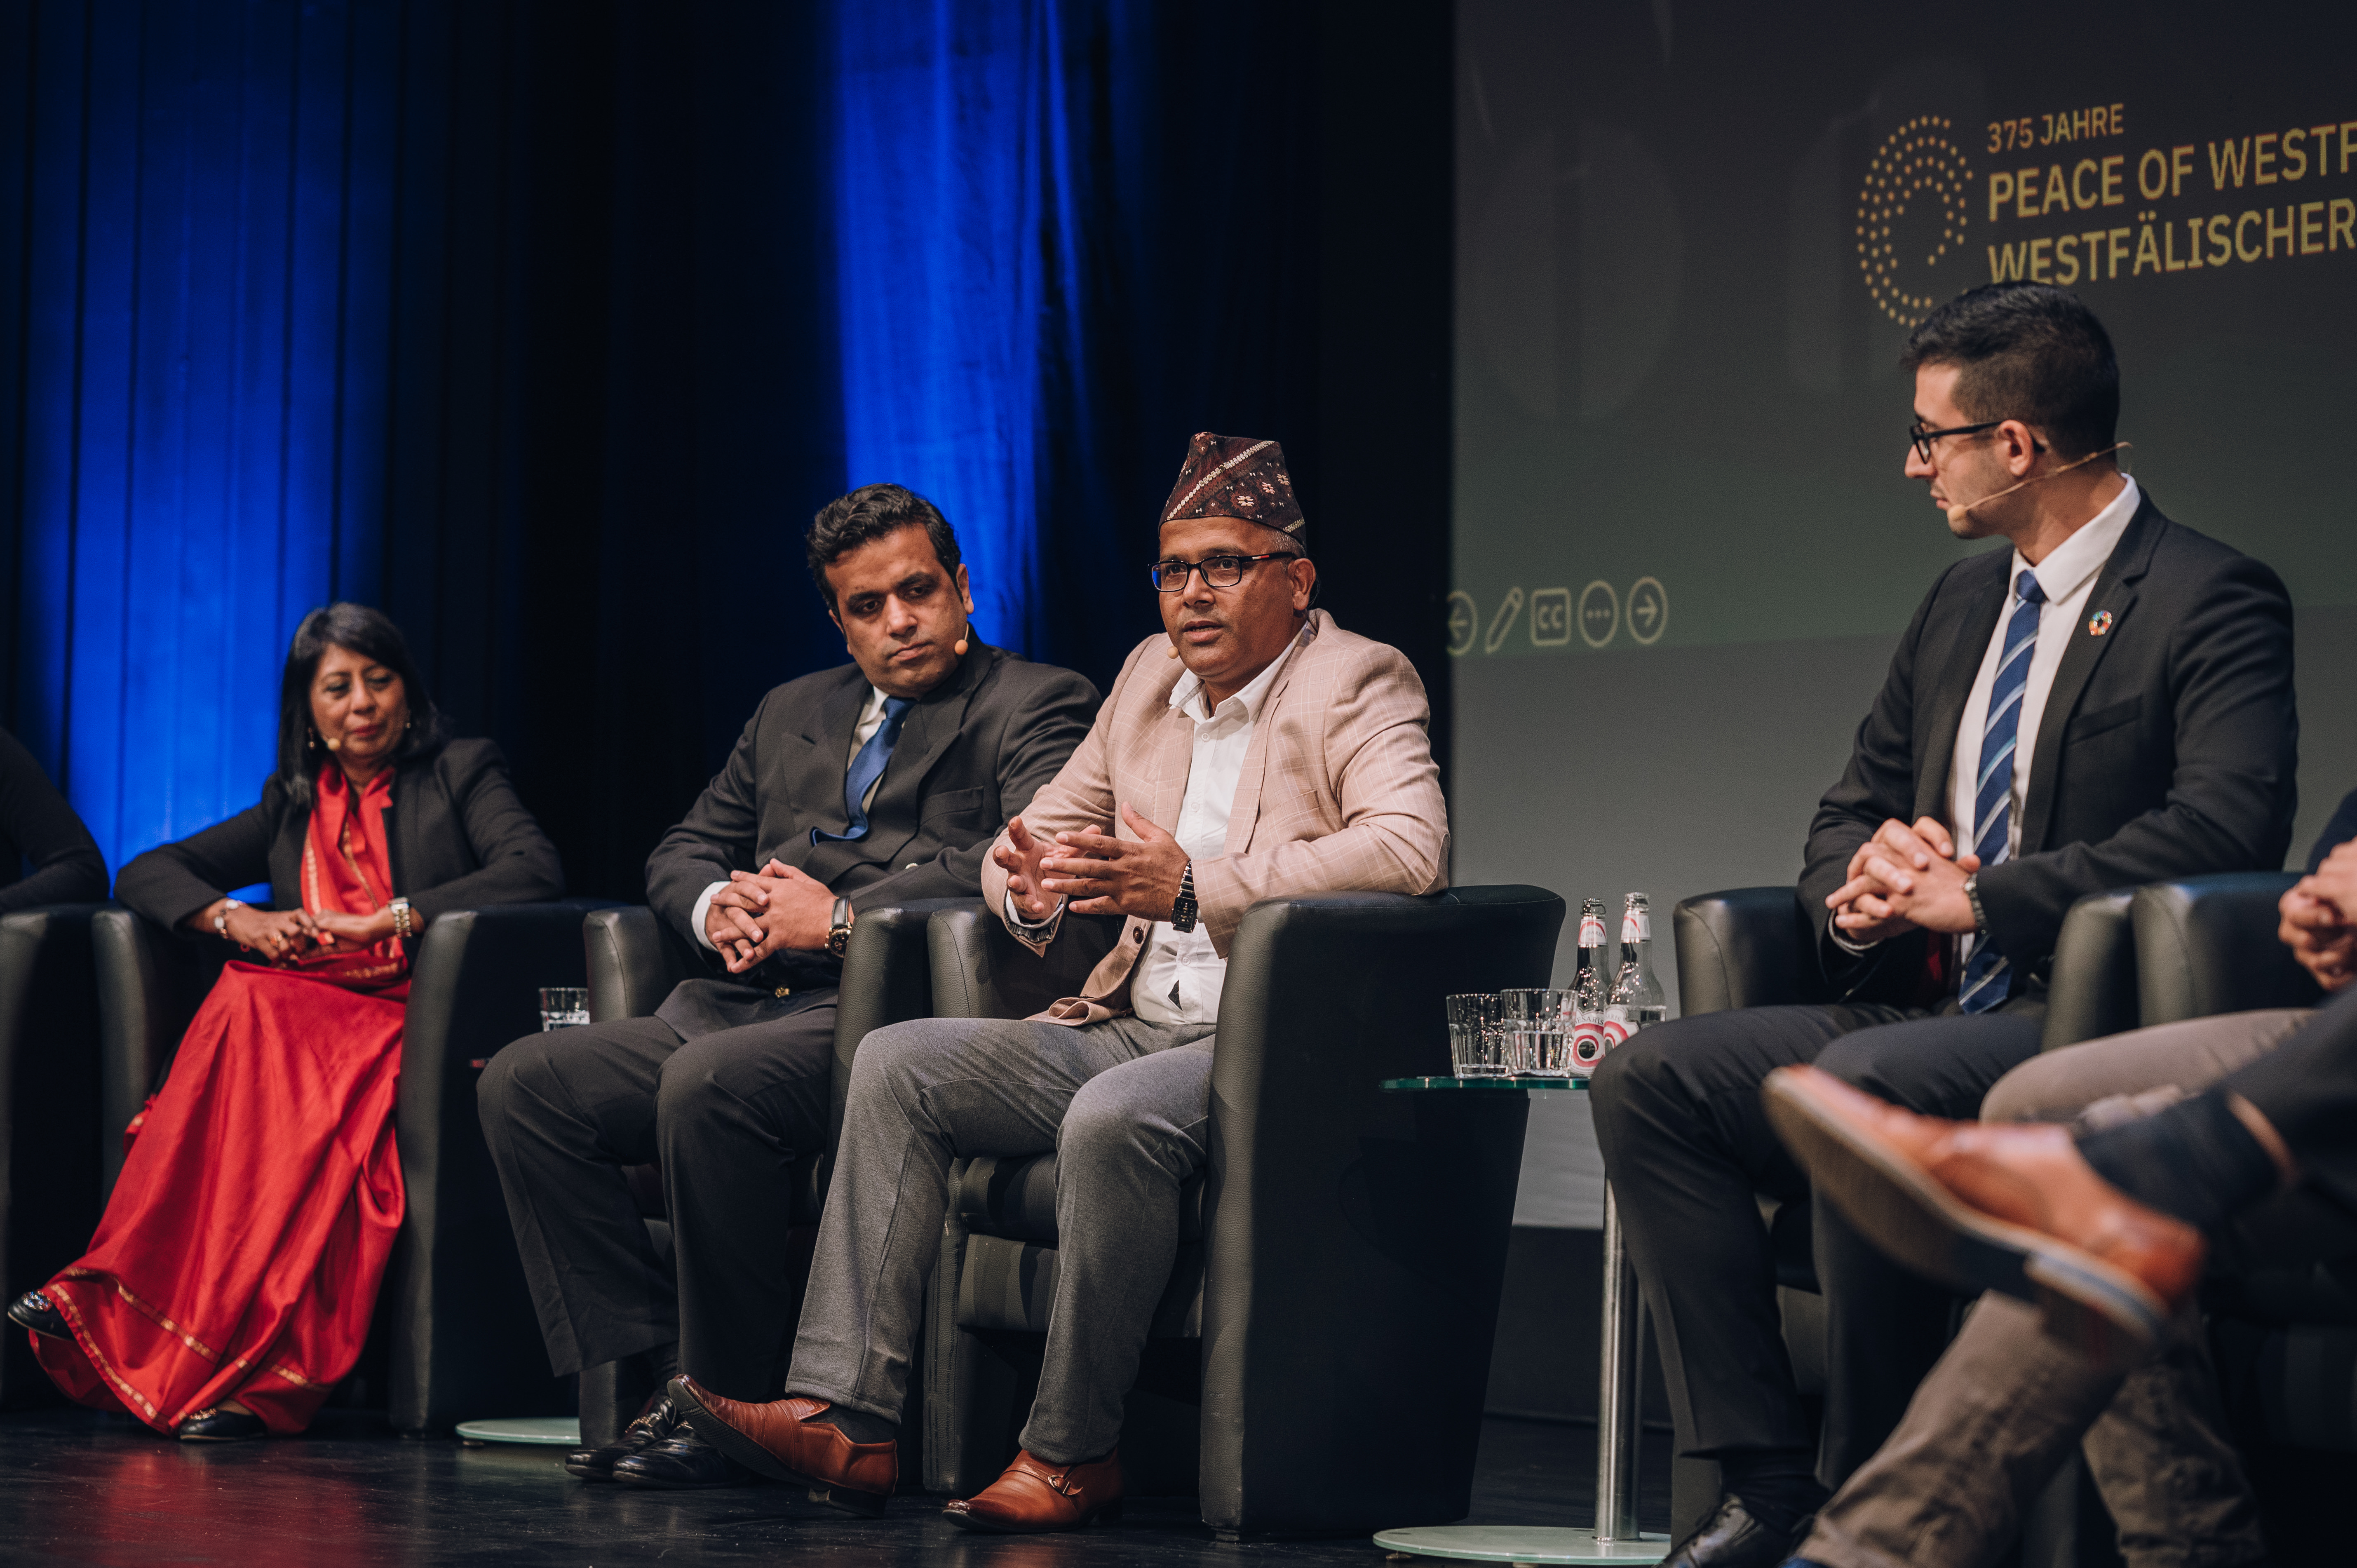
1761, 1068, 2206, 1363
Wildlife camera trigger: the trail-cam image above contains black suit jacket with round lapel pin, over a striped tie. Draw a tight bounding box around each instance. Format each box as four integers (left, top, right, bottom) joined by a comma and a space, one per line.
1801, 493, 2301, 1002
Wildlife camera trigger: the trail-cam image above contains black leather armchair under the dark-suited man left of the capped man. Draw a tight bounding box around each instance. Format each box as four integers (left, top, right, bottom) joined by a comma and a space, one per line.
580, 898, 969, 1474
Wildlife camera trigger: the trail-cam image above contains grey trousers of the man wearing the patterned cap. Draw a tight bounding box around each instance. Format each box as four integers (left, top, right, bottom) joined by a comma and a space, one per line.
787, 1019, 1211, 1464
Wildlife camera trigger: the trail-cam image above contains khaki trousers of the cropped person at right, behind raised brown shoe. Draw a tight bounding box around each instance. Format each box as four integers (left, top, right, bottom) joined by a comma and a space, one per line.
1796, 1009, 2308, 1568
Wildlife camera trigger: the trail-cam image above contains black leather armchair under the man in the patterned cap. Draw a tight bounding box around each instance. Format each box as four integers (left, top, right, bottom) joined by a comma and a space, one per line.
926, 887, 1563, 1540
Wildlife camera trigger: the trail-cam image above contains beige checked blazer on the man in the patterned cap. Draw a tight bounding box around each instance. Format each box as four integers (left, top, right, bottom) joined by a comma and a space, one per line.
983, 611, 1450, 1023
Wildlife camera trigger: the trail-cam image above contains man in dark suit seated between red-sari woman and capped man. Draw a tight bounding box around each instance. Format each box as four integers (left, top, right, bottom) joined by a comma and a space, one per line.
481, 486, 1099, 1486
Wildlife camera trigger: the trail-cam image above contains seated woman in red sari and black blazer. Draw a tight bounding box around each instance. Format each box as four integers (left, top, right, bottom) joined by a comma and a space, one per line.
7, 603, 563, 1441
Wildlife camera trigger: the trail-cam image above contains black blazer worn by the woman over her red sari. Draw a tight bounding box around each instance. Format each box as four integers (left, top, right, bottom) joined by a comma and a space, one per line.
115, 740, 566, 929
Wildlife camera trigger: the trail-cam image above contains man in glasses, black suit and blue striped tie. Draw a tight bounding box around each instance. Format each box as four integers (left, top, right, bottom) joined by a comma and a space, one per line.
1593, 283, 2298, 1568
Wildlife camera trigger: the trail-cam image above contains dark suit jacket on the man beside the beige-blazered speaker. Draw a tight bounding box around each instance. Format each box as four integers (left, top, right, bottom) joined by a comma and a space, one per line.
646, 644, 1099, 1038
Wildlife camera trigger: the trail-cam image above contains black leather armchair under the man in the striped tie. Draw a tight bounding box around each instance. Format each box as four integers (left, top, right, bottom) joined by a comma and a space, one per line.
1671, 887, 2140, 1533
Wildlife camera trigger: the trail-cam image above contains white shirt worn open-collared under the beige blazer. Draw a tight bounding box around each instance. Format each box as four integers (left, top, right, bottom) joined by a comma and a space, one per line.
1007, 636, 1301, 1023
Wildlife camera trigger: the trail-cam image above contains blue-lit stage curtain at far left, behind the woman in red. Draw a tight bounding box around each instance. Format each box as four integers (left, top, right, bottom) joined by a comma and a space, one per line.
0, 0, 415, 865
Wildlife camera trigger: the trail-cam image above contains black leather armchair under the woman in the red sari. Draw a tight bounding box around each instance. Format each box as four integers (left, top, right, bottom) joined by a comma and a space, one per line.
92, 898, 603, 1434
